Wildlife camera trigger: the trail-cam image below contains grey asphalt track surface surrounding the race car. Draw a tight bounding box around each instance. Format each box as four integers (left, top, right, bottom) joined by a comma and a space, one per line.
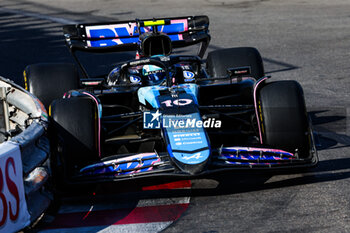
0, 0, 350, 233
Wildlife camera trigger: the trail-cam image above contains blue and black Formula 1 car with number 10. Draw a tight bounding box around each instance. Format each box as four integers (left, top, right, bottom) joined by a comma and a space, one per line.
25, 16, 318, 184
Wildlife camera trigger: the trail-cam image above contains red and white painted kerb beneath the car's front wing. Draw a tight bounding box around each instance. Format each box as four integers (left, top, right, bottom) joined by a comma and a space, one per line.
39, 180, 191, 233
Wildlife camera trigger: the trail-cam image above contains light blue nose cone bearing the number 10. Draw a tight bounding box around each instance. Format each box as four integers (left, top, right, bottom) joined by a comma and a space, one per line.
137, 83, 210, 169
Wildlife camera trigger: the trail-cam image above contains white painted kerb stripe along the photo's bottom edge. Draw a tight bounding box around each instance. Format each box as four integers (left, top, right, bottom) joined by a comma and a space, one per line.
40, 221, 172, 233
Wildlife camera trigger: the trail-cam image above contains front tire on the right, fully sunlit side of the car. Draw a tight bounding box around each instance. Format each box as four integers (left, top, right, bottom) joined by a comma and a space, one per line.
258, 81, 310, 158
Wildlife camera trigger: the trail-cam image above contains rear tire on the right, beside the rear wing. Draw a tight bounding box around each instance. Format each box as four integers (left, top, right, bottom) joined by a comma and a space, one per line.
207, 47, 265, 79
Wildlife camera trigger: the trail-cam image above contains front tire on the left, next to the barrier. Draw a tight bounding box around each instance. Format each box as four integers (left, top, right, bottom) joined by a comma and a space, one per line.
50, 97, 99, 183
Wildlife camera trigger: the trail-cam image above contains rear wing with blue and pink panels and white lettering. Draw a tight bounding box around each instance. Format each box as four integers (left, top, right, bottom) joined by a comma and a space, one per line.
63, 16, 210, 57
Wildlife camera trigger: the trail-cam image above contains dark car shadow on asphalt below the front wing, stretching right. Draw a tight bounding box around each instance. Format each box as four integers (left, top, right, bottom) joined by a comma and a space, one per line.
121, 154, 350, 199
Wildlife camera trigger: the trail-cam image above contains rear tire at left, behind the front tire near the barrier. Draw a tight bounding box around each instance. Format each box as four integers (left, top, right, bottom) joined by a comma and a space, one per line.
23, 63, 79, 109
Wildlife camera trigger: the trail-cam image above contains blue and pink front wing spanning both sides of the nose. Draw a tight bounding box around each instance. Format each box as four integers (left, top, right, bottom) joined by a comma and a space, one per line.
72, 147, 318, 183
